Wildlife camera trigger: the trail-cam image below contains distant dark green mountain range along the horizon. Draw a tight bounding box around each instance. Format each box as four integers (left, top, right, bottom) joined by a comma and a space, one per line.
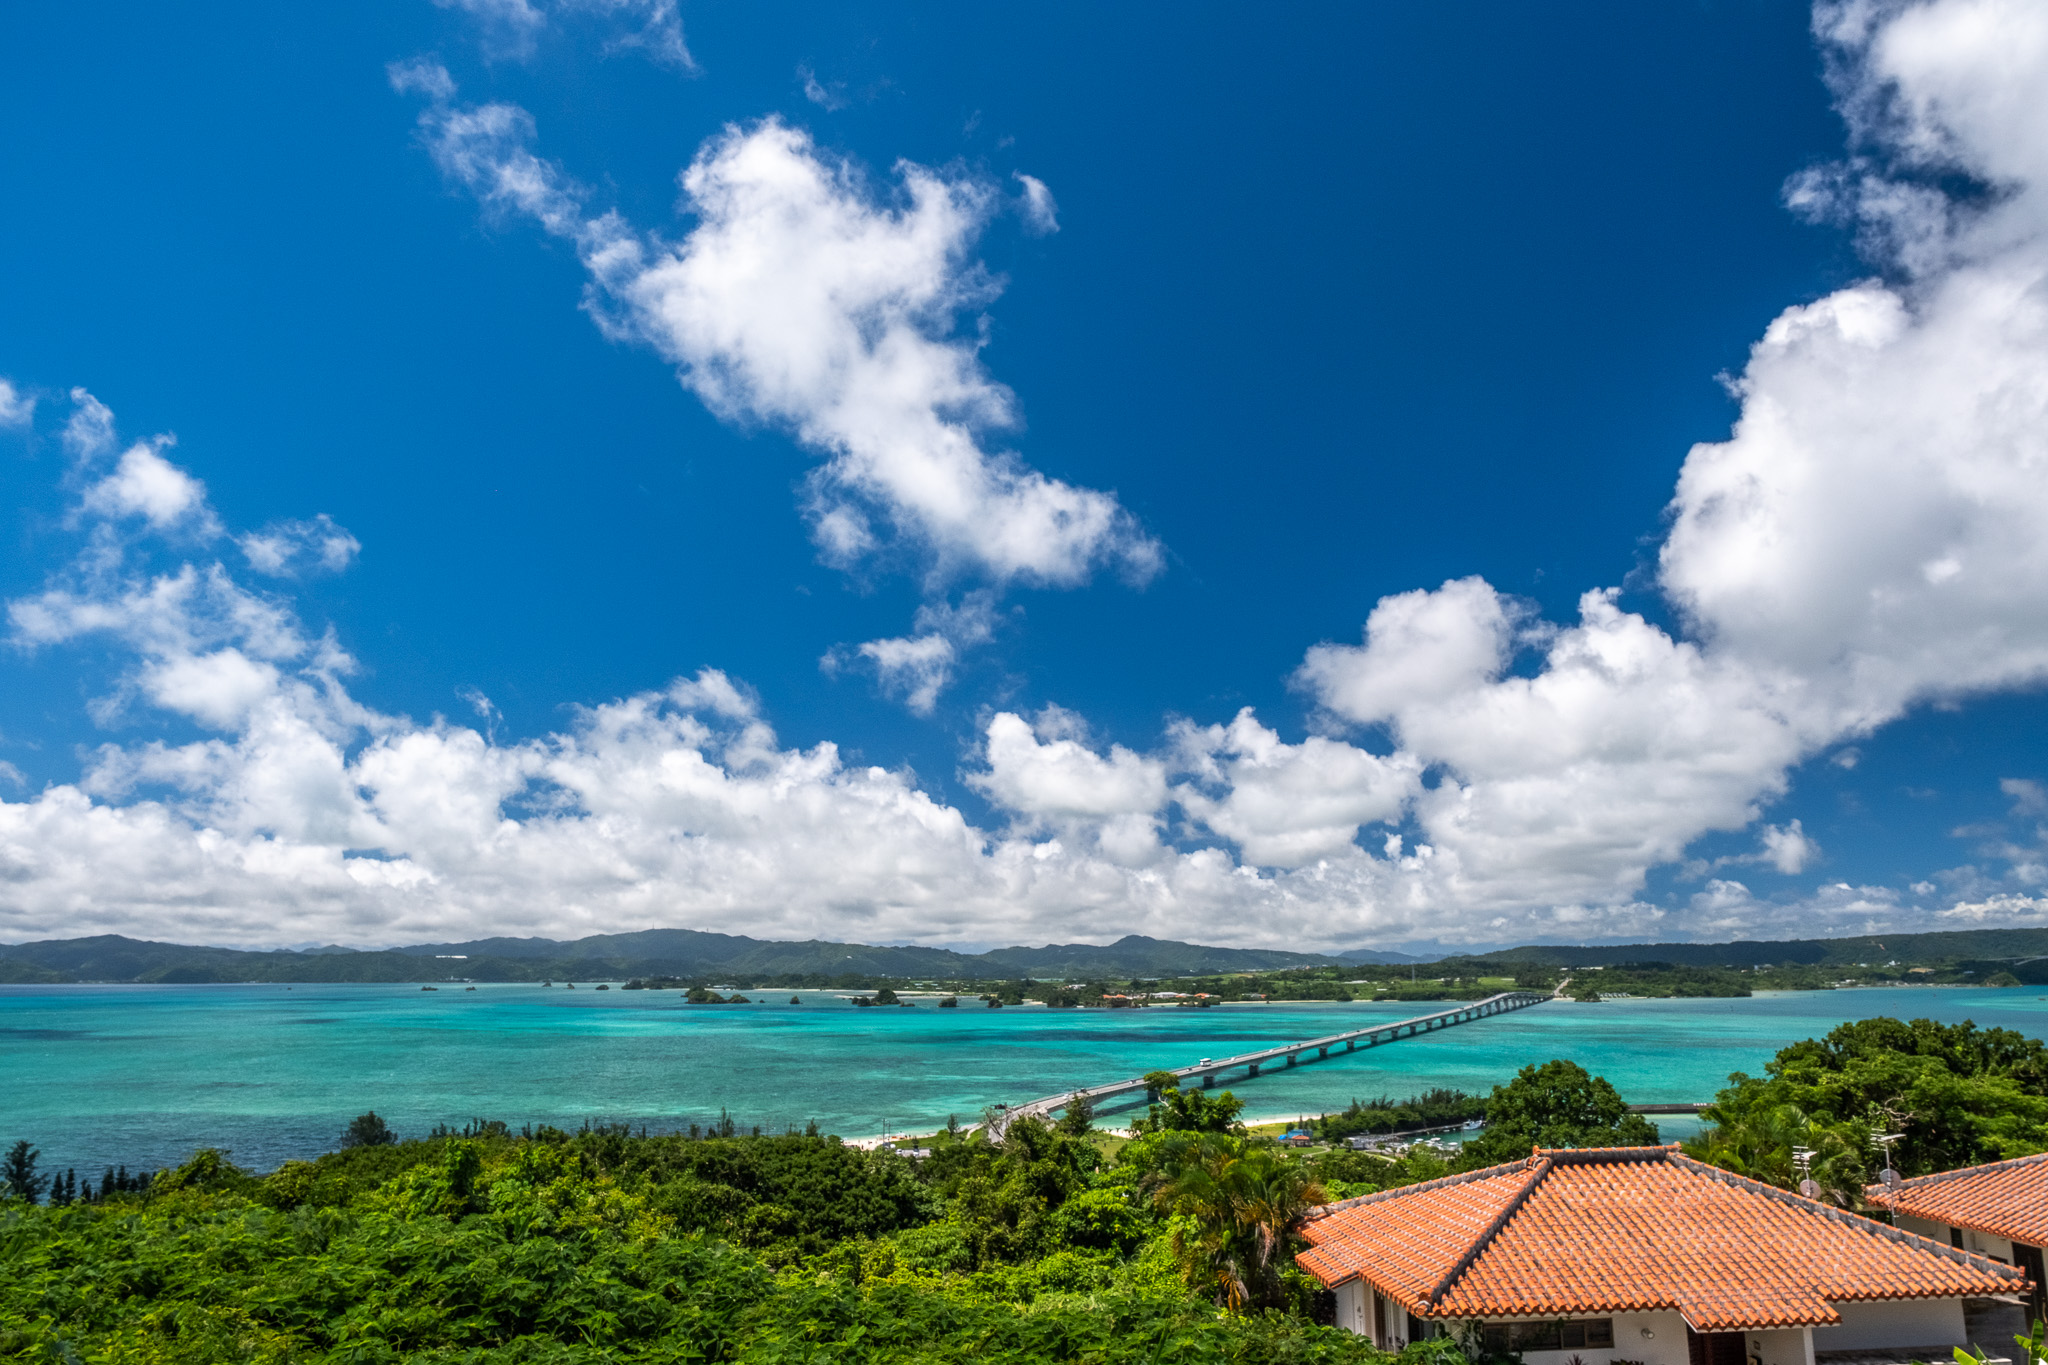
0, 929, 2048, 984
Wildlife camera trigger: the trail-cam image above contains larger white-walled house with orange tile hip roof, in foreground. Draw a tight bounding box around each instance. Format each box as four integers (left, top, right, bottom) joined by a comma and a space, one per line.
1296, 1146, 2028, 1365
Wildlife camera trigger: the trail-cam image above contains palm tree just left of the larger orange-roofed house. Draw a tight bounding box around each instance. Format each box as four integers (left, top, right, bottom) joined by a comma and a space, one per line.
1153, 1134, 1325, 1312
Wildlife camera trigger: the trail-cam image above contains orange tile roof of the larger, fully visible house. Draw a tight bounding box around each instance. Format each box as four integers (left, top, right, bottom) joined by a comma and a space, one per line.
1296, 1146, 2025, 1332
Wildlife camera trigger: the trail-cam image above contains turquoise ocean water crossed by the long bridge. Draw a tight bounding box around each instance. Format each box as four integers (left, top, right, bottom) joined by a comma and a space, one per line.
0, 984, 2048, 1173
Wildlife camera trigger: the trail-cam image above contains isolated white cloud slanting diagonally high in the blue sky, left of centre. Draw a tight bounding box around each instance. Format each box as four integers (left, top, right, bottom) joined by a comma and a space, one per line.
407, 104, 1161, 585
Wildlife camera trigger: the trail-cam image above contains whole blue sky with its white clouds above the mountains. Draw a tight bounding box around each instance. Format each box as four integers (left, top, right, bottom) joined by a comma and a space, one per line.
0, 0, 2048, 948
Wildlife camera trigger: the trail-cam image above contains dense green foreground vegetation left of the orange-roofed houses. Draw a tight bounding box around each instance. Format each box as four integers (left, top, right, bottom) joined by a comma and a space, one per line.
0, 1115, 1433, 1365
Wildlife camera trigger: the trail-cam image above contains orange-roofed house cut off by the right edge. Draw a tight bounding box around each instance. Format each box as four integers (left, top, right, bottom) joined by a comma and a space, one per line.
1864, 1152, 2048, 1322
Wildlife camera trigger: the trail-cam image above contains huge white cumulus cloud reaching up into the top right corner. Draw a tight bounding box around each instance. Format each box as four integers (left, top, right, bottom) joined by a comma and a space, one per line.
1298, 0, 2048, 916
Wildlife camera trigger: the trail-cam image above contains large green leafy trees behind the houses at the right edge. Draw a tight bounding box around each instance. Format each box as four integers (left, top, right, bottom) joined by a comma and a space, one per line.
1690, 1019, 2048, 1205
